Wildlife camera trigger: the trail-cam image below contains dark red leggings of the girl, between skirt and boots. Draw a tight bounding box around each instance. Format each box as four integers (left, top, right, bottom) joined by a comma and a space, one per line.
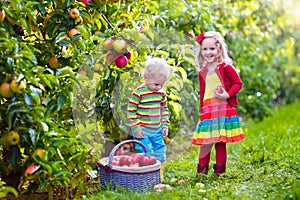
198, 143, 227, 165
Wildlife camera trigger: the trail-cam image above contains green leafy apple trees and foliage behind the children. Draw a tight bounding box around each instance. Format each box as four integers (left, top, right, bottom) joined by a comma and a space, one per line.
0, 0, 300, 198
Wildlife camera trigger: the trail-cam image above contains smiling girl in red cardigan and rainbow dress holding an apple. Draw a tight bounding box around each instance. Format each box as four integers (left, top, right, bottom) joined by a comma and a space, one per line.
191, 31, 245, 177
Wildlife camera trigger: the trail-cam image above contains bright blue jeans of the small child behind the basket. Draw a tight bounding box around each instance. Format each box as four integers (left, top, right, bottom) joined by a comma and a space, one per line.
133, 127, 167, 162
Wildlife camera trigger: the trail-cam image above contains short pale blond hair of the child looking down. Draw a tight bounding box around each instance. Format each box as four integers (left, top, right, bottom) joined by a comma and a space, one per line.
142, 57, 172, 79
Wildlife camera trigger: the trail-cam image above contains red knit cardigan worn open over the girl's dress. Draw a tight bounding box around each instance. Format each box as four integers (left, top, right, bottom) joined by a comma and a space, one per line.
198, 63, 242, 108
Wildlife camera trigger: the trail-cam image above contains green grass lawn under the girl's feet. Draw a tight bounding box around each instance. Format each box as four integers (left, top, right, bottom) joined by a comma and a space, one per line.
82, 102, 300, 200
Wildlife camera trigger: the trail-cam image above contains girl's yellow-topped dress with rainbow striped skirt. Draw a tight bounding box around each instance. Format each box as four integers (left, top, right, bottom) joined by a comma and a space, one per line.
191, 72, 245, 145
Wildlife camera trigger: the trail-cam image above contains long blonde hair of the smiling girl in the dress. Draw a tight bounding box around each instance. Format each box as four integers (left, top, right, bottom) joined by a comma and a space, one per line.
195, 31, 232, 71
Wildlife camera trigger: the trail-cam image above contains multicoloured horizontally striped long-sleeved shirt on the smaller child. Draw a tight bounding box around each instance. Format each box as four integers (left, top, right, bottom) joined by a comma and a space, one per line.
127, 84, 170, 132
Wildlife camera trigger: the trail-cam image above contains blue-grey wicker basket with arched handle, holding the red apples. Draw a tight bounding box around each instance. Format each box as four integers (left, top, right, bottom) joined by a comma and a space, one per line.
99, 140, 161, 192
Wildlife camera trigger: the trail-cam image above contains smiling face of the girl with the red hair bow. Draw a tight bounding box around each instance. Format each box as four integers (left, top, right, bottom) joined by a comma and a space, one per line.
201, 38, 220, 65
